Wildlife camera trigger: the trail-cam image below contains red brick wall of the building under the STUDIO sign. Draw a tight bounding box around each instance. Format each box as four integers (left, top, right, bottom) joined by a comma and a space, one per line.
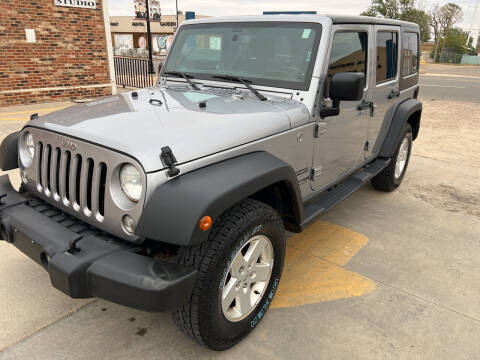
0, 0, 112, 107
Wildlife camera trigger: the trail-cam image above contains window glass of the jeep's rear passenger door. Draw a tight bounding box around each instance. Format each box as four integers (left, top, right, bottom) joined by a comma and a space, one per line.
377, 31, 398, 84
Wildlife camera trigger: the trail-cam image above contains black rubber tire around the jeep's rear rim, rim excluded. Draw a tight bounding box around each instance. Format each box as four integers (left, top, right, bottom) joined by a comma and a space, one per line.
372, 123, 413, 192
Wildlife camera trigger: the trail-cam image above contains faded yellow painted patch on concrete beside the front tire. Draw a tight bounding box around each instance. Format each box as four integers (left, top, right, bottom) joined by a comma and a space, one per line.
271, 221, 376, 308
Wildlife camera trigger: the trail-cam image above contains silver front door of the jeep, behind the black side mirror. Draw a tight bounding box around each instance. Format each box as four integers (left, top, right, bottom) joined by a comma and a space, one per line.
311, 24, 373, 190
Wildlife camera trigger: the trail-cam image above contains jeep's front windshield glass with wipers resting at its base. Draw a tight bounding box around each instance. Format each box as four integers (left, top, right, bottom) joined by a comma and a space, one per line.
162, 22, 321, 90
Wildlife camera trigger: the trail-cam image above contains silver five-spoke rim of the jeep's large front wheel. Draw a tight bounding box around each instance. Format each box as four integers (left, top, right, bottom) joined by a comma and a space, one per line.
222, 235, 274, 322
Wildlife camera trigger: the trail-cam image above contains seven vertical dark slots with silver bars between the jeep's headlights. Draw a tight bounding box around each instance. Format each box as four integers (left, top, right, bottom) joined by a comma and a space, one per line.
35, 141, 107, 222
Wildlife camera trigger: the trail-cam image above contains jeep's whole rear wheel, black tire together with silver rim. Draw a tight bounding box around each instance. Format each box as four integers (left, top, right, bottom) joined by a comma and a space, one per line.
372, 123, 413, 192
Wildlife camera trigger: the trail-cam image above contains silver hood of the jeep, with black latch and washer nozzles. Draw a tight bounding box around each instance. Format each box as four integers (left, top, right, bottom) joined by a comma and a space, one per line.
27, 85, 309, 172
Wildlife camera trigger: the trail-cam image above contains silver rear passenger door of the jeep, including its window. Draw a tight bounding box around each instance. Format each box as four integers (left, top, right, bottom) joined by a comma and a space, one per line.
365, 25, 401, 158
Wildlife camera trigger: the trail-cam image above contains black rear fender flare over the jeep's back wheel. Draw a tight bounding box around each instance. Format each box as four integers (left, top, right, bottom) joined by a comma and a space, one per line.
379, 99, 422, 158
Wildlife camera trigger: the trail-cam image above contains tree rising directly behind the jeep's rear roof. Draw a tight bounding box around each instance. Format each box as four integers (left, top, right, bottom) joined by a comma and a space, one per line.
361, 0, 430, 41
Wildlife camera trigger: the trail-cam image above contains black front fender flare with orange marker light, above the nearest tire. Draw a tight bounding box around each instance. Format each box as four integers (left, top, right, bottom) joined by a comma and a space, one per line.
136, 152, 303, 246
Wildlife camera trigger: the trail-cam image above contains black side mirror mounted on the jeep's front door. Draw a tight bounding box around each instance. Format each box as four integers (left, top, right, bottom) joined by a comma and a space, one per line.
320, 72, 365, 119
